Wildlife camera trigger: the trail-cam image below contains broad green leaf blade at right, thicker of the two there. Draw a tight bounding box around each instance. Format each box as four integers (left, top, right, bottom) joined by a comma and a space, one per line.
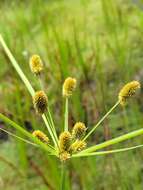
80, 126, 143, 154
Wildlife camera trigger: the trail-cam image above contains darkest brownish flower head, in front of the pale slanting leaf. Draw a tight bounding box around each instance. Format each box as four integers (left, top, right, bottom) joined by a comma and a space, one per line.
33, 90, 48, 114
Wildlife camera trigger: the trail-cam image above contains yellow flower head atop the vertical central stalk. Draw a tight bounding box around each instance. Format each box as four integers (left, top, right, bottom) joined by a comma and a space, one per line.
63, 77, 76, 97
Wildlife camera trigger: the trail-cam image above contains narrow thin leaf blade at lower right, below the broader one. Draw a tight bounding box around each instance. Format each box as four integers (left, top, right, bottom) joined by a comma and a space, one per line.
72, 144, 143, 157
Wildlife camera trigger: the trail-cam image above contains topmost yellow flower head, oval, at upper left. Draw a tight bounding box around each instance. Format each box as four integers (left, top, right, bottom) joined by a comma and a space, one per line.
29, 55, 43, 74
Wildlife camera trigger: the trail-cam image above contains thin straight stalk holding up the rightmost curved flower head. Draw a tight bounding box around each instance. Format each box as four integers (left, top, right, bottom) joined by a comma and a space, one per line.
83, 101, 120, 141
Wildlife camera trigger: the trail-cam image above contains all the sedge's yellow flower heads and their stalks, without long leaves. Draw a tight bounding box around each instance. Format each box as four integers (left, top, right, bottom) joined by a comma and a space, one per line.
27, 55, 140, 161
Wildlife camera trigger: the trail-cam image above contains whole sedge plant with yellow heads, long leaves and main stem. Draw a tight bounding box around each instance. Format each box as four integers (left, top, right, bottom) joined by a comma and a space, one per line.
0, 36, 143, 189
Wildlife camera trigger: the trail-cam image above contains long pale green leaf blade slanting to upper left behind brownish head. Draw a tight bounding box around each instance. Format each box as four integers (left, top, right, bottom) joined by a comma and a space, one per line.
0, 35, 56, 147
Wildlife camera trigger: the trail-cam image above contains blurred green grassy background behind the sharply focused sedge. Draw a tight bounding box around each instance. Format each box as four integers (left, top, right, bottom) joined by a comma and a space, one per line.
0, 0, 143, 190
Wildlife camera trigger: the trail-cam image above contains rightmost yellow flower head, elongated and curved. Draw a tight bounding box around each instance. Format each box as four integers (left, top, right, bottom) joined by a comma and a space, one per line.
118, 81, 140, 106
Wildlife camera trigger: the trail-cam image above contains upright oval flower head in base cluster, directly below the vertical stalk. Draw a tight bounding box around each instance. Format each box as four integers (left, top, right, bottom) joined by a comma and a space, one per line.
59, 131, 72, 152
